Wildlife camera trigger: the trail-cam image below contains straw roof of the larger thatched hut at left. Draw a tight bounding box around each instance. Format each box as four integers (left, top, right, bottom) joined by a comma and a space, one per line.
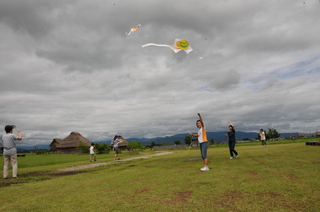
50, 132, 91, 148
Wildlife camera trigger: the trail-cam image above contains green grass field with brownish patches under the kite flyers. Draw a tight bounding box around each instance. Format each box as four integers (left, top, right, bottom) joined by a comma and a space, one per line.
0, 142, 320, 211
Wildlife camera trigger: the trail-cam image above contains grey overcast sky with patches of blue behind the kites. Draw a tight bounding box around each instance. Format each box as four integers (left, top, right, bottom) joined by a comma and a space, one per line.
0, 0, 320, 145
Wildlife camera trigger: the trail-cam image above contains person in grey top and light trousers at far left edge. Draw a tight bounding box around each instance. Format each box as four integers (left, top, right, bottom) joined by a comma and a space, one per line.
1, 125, 22, 179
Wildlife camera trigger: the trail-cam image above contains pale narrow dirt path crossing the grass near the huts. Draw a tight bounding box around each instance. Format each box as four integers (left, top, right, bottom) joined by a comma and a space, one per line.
56, 152, 173, 172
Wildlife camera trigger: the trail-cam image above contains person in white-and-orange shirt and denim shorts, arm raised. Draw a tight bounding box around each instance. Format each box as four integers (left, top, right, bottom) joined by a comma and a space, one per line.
189, 113, 209, 171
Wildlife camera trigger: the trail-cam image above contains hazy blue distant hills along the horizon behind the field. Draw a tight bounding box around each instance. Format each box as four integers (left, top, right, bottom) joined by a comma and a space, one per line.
17, 131, 299, 152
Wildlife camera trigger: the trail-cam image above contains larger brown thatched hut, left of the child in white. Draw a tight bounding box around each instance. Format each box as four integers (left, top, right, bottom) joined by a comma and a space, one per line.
50, 132, 91, 154
